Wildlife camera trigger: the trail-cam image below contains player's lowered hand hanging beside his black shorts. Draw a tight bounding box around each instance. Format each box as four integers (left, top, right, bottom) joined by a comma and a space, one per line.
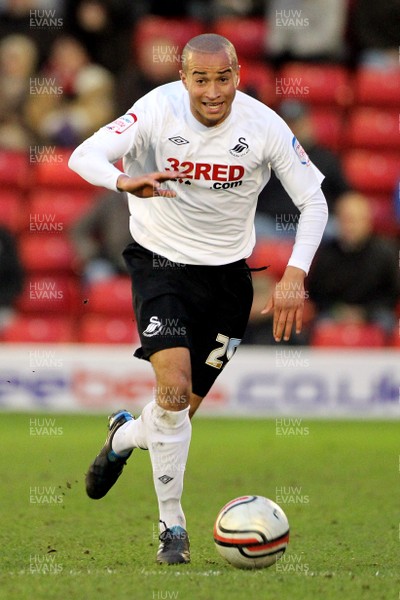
261, 267, 306, 342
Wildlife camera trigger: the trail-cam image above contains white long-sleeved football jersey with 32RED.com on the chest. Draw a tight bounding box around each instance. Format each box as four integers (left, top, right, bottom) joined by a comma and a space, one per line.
70, 81, 326, 272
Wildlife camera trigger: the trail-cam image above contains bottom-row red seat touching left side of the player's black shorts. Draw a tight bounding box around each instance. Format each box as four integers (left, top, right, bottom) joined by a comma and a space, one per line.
78, 313, 140, 344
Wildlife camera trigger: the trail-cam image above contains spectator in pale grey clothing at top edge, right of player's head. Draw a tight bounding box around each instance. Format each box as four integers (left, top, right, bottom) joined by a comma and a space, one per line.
266, 0, 348, 64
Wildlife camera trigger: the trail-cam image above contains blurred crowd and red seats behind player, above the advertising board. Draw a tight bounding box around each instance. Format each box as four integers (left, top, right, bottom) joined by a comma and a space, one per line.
0, 0, 400, 347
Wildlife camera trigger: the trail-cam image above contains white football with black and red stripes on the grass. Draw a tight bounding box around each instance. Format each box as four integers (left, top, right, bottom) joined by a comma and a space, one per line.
214, 496, 289, 569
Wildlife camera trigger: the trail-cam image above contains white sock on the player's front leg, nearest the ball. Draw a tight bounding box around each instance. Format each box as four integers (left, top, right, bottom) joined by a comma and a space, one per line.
142, 403, 192, 531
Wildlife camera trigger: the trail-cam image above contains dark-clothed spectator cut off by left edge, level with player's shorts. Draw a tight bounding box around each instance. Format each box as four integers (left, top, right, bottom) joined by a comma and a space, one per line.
0, 225, 24, 332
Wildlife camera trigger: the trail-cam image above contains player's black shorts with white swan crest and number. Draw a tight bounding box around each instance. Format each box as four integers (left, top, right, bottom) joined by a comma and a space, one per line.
123, 242, 253, 397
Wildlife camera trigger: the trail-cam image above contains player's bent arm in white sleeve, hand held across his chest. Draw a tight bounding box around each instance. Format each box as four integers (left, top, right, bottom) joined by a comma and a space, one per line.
68, 113, 178, 198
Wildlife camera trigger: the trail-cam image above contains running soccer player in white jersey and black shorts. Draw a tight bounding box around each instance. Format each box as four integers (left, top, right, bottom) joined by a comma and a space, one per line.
69, 34, 327, 564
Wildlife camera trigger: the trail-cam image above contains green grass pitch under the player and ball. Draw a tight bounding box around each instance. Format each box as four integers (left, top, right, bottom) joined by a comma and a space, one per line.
0, 413, 400, 600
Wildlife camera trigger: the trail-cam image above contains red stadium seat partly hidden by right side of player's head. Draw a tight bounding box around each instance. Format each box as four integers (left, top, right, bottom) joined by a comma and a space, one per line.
213, 17, 267, 63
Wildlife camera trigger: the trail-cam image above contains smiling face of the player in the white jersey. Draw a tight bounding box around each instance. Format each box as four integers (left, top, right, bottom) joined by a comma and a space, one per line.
180, 50, 239, 127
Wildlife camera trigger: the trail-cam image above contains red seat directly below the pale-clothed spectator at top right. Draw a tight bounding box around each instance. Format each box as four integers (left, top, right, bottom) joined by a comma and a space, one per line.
276, 62, 351, 106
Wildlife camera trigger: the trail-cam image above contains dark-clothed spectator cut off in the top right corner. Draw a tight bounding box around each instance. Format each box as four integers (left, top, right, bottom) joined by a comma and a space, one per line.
350, 0, 400, 69
